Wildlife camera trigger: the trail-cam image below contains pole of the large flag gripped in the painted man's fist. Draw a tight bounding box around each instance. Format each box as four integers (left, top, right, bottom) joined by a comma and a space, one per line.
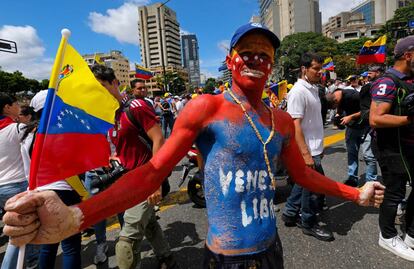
16, 28, 71, 269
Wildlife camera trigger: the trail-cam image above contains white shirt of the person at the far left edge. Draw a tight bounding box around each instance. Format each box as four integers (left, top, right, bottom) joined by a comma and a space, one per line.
0, 123, 26, 186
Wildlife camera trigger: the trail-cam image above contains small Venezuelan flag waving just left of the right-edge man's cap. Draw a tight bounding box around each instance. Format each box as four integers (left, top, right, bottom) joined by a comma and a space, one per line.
357, 35, 387, 64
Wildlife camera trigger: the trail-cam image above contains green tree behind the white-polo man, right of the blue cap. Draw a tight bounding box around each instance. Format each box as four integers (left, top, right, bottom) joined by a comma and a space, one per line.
276, 32, 338, 81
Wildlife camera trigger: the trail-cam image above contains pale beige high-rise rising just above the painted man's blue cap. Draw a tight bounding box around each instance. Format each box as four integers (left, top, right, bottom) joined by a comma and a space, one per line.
259, 0, 322, 39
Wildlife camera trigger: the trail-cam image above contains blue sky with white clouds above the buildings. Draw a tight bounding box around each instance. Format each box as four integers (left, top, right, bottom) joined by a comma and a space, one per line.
0, 0, 360, 80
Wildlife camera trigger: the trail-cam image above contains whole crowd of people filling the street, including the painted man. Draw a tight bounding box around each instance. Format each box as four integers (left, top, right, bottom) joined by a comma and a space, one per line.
0, 24, 414, 269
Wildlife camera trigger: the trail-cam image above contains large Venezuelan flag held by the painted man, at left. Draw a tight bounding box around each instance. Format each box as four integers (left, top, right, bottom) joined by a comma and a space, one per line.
30, 44, 119, 189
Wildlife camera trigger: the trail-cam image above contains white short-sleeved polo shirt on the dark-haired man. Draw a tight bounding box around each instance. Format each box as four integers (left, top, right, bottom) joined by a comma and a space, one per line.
287, 79, 323, 156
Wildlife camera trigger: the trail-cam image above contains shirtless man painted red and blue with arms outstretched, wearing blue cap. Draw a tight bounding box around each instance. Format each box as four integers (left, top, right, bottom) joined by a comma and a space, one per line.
3, 24, 383, 268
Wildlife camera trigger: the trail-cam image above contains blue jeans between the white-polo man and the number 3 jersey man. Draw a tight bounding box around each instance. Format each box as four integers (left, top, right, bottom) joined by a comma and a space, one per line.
345, 127, 377, 182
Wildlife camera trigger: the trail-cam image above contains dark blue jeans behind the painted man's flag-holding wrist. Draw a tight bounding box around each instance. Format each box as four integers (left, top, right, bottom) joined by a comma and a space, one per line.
39, 190, 82, 269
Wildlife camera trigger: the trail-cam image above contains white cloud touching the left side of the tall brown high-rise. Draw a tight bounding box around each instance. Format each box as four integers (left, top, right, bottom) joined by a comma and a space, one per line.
88, 0, 149, 45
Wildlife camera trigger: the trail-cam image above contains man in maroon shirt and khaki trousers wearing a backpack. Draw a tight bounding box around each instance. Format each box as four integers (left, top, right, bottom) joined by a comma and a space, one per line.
110, 80, 175, 269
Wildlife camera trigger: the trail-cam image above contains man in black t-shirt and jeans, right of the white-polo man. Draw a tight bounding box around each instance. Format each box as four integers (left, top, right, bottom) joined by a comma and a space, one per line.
327, 86, 377, 187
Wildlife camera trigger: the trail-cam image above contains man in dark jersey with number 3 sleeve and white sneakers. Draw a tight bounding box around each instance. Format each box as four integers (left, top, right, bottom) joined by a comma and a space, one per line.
369, 36, 414, 261
